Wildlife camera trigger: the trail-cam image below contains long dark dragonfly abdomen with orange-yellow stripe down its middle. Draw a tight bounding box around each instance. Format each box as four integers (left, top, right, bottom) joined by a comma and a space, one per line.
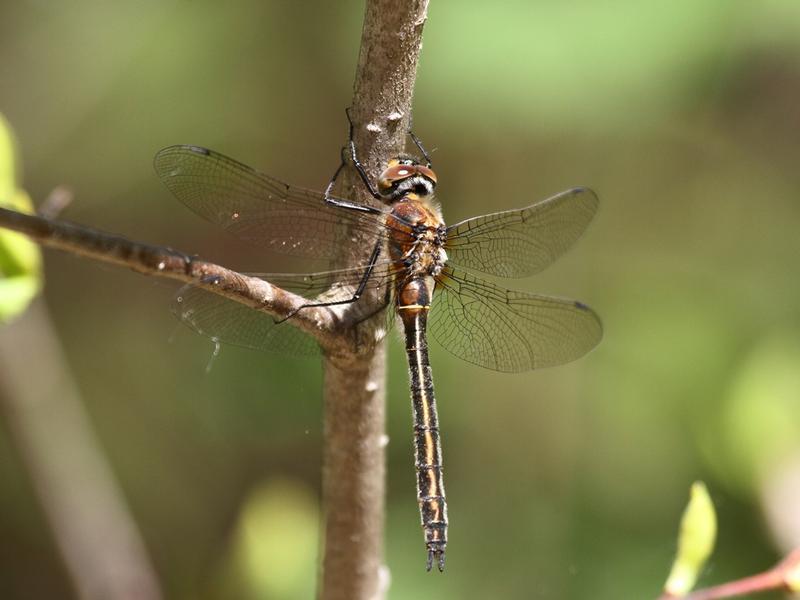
397, 278, 447, 571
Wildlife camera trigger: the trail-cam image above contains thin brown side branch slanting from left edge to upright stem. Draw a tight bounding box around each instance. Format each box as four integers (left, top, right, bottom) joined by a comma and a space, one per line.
0, 208, 342, 347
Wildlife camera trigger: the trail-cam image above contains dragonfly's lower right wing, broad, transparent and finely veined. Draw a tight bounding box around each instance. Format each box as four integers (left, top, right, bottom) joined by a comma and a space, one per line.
428, 268, 603, 372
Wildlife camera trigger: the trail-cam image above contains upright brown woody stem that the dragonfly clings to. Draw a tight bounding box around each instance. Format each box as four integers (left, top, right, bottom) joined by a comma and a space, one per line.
320, 0, 428, 600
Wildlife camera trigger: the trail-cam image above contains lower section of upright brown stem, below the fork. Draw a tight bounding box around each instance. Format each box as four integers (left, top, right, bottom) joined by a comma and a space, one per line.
321, 344, 386, 600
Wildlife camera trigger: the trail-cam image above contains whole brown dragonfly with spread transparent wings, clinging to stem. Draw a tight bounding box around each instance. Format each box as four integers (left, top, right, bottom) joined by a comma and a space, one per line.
154, 123, 602, 571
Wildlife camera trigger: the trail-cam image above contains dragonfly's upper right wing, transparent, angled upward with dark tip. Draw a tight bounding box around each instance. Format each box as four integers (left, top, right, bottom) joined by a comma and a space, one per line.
445, 188, 599, 277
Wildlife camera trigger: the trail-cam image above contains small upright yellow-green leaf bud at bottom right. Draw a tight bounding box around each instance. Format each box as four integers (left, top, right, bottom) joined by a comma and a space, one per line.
664, 481, 717, 598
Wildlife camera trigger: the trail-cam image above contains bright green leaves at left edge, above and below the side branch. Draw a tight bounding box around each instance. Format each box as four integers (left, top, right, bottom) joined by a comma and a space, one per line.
0, 113, 42, 324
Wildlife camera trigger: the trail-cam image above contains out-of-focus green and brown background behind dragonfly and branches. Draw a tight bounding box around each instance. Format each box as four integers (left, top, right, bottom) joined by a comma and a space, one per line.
0, 0, 800, 600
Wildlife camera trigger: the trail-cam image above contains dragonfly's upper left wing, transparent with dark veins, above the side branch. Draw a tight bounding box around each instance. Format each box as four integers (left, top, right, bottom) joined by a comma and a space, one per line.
153, 146, 390, 258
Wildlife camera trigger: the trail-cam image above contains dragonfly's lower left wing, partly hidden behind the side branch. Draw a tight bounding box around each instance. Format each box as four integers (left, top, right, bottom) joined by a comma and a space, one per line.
172, 261, 404, 356
